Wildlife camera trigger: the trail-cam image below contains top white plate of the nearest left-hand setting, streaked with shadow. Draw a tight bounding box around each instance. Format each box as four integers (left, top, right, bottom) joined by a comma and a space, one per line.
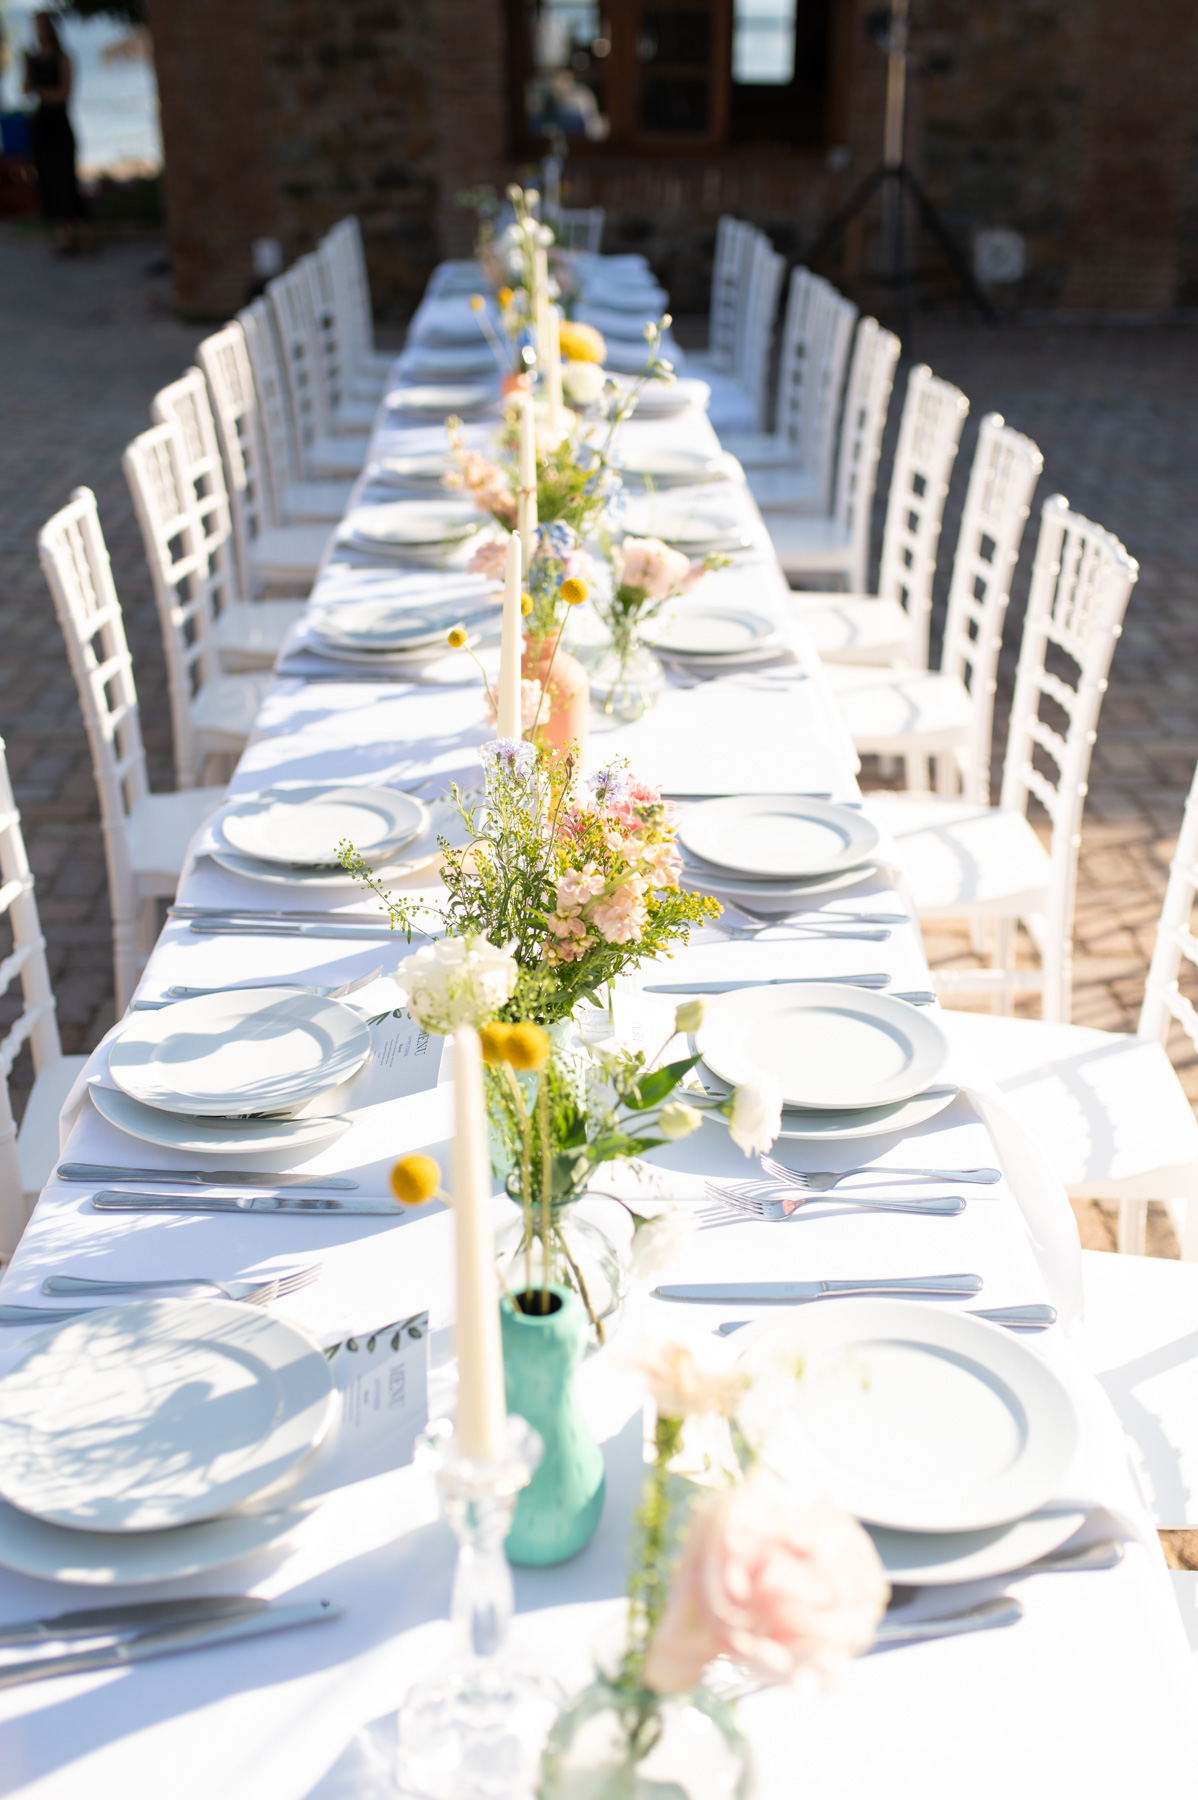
0, 1300, 336, 1532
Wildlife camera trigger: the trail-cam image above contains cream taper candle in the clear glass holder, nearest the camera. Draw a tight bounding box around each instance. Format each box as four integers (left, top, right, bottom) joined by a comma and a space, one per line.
453, 1024, 507, 1462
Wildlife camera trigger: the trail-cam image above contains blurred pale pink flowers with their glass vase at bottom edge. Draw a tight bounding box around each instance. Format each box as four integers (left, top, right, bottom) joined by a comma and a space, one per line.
536, 1345, 889, 1800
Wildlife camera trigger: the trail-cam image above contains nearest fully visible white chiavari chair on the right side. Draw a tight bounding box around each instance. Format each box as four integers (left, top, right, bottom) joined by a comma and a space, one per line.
863, 493, 1139, 1022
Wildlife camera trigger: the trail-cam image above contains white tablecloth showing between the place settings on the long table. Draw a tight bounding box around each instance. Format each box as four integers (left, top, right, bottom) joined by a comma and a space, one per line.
0, 266, 1198, 1800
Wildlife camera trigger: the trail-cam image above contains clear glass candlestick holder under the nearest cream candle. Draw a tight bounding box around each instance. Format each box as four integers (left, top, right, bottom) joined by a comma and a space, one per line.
398, 1415, 563, 1800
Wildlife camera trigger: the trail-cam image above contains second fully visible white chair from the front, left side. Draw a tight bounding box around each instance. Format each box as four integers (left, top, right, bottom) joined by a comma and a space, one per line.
121, 425, 272, 788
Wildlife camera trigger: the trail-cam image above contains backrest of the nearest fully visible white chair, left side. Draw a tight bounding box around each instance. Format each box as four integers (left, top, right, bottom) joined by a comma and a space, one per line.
34, 488, 149, 993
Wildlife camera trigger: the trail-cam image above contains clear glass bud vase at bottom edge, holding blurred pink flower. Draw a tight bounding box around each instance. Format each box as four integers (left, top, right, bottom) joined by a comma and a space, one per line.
536, 1674, 752, 1800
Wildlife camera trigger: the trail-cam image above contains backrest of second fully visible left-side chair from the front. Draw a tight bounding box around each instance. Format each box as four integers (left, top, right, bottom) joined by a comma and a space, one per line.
121, 423, 228, 788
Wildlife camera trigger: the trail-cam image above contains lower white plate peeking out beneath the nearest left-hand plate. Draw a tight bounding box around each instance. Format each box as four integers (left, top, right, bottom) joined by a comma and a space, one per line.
0, 1501, 315, 1588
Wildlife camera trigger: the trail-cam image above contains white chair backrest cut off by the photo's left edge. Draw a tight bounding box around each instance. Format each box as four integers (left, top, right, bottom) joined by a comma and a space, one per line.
0, 738, 63, 1258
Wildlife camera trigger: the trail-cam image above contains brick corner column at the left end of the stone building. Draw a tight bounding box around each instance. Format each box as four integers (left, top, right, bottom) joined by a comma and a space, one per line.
148, 0, 275, 319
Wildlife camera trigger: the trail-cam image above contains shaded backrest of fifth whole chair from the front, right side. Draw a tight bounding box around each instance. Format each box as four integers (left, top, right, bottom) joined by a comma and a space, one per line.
773, 266, 856, 513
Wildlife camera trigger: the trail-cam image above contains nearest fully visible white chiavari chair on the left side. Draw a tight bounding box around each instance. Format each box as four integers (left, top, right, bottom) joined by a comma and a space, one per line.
38, 493, 225, 1013
